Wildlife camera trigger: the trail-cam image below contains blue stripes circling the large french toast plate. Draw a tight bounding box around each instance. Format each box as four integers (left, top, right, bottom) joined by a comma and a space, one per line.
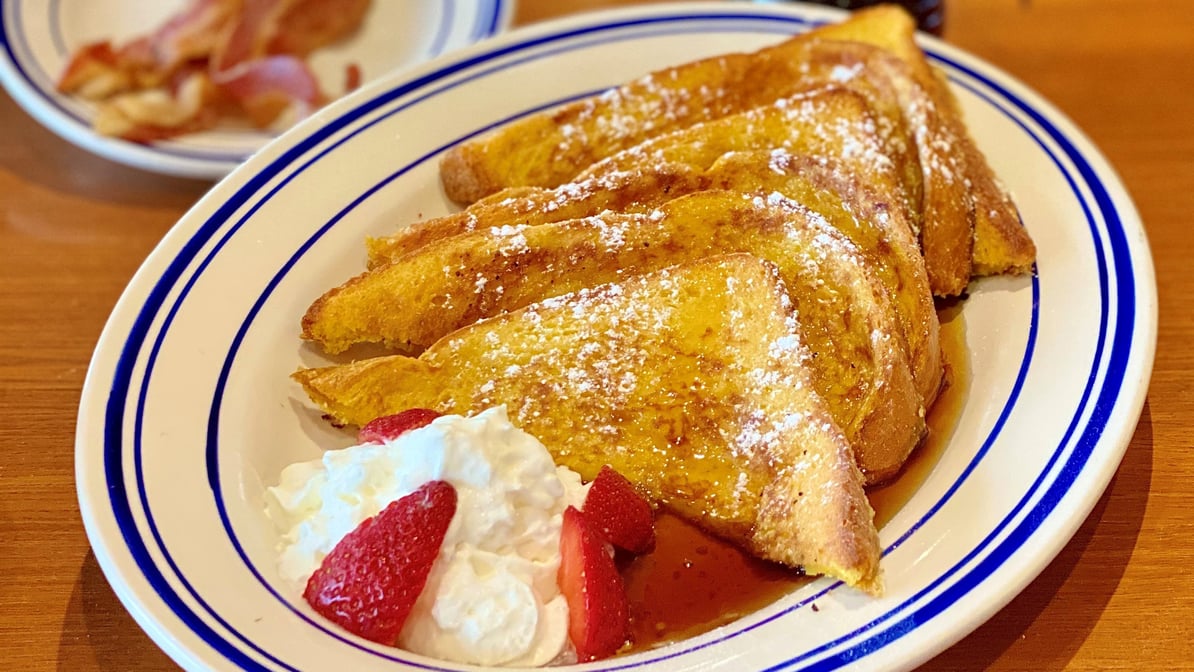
90, 6, 1135, 670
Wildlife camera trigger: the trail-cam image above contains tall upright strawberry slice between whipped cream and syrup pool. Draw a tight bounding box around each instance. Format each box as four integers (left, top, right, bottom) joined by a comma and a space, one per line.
556, 506, 630, 662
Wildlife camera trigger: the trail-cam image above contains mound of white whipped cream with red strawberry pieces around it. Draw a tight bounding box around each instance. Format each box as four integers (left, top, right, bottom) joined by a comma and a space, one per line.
269, 407, 653, 666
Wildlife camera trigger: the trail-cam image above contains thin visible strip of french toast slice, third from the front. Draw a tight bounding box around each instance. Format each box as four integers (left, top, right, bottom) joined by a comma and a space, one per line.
367, 150, 942, 406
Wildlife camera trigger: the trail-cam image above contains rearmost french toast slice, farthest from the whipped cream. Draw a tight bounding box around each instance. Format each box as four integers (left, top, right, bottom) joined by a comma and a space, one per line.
441, 7, 1035, 296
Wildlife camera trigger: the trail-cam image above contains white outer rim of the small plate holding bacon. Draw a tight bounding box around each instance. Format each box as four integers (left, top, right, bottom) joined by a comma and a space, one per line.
0, 0, 517, 180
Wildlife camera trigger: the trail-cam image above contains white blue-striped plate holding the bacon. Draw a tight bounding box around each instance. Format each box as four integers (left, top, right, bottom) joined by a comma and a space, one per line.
0, 0, 513, 179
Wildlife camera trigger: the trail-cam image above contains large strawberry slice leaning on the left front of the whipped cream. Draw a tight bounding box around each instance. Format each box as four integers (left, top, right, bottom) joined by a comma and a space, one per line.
303, 481, 456, 646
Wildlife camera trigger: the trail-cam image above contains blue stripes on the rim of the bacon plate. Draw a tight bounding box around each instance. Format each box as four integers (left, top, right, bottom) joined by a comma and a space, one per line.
0, 0, 511, 164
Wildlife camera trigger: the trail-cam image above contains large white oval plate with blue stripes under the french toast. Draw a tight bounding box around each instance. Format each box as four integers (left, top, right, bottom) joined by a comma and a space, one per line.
76, 4, 1157, 671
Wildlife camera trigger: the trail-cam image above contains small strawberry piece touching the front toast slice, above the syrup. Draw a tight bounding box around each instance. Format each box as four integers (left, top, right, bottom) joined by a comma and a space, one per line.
584, 464, 656, 554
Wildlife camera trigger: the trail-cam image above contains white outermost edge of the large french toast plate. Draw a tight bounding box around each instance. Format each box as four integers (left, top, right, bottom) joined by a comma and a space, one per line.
76, 4, 1157, 660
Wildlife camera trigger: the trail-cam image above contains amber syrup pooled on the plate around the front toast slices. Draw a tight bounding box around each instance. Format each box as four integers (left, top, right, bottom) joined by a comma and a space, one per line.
622, 302, 970, 652
